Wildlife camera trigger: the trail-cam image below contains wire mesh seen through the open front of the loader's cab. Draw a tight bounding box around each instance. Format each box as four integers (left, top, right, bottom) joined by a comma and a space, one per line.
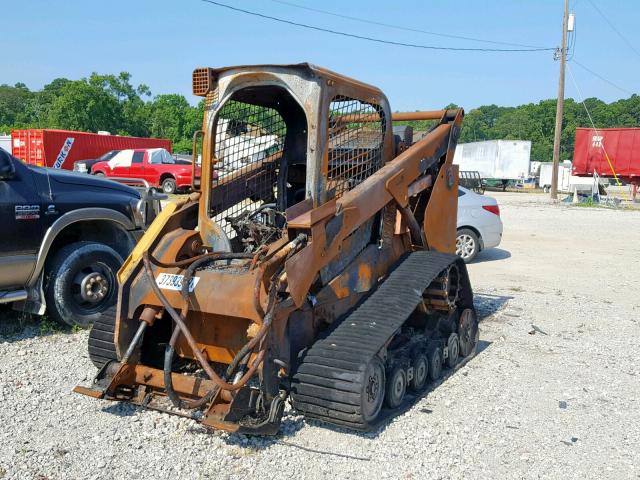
211, 100, 286, 238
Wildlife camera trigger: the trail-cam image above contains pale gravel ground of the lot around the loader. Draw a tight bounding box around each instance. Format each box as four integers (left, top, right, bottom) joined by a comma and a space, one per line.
0, 193, 640, 480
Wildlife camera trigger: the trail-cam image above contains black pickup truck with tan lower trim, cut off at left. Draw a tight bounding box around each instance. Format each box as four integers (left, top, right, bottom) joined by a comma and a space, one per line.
0, 149, 159, 325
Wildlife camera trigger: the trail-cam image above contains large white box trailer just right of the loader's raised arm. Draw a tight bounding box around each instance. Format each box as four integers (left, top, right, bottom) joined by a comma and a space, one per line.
453, 140, 531, 180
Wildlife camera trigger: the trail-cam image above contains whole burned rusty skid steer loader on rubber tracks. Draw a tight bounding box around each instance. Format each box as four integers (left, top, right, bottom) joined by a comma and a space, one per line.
76, 64, 478, 434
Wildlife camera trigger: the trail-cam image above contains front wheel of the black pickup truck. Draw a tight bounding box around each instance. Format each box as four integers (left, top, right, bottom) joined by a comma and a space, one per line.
45, 242, 123, 327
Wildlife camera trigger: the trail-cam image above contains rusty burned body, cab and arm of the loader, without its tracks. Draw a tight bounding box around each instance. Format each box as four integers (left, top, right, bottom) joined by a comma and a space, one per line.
74, 64, 463, 434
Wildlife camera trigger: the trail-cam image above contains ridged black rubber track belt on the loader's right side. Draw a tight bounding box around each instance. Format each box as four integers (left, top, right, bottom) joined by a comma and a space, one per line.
291, 251, 457, 429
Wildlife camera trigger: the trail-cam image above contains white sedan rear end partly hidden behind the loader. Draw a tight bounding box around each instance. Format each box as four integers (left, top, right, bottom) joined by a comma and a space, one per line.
456, 187, 502, 263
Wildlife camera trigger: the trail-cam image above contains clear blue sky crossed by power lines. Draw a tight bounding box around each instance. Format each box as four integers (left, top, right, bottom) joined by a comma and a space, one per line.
0, 0, 640, 110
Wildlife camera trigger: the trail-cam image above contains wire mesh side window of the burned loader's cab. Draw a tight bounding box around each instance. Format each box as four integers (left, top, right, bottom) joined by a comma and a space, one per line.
327, 96, 385, 197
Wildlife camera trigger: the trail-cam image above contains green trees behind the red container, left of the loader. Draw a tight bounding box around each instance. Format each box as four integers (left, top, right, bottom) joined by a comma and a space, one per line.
0, 72, 204, 152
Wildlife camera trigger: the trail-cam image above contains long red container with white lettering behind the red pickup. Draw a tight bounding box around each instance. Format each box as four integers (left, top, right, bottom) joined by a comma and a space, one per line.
11, 128, 171, 170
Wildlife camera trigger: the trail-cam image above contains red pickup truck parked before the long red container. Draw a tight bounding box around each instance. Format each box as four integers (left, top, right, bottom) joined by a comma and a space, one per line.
91, 148, 194, 193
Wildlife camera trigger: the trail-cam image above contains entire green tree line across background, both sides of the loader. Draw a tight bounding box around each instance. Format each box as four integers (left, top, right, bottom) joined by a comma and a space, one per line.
0, 72, 640, 156
